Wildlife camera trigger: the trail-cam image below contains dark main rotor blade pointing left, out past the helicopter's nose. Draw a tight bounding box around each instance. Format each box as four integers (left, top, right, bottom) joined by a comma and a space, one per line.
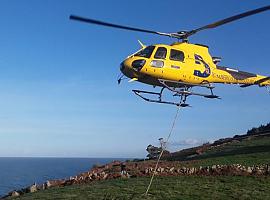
69, 15, 171, 36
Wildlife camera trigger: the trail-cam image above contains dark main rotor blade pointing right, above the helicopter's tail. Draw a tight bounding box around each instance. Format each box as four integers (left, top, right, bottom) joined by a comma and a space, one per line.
184, 5, 270, 38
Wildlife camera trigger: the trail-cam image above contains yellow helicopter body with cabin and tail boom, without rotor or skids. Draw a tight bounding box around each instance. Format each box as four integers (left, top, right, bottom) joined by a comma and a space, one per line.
120, 42, 270, 87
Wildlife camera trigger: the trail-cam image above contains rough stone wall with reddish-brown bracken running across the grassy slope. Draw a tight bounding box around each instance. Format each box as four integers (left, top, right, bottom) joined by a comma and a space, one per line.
3, 161, 270, 198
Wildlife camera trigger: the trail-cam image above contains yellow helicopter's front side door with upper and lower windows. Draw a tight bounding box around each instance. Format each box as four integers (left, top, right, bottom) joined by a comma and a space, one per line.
150, 47, 167, 78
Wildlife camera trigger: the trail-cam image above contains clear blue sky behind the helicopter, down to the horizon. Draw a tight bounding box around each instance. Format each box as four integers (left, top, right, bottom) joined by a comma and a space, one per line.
0, 0, 270, 158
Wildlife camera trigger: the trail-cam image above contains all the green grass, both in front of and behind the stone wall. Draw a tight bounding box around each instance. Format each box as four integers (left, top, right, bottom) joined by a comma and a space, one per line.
6, 134, 270, 200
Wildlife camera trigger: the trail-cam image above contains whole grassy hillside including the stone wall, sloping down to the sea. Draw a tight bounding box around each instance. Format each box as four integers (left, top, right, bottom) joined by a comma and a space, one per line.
3, 132, 270, 200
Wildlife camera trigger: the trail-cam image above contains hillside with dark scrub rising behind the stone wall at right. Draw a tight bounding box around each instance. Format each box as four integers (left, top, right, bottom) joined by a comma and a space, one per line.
165, 132, 270, 166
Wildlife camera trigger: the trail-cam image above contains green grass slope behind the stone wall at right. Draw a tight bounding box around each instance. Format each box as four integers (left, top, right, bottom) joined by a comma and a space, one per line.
169, 137, 270, 166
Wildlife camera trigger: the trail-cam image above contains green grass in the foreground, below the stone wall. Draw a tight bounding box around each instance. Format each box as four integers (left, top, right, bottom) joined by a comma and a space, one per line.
13, 176, 270, 200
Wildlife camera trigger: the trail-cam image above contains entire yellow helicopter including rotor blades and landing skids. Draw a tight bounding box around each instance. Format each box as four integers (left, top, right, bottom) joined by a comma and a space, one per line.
70, 6, 270, 107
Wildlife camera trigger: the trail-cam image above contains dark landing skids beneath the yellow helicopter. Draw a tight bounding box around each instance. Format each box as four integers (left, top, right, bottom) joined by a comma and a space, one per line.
132, 79, 220, 107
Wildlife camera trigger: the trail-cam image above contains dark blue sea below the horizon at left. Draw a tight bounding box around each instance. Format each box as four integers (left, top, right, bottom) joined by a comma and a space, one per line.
0, 158, 126, 197
